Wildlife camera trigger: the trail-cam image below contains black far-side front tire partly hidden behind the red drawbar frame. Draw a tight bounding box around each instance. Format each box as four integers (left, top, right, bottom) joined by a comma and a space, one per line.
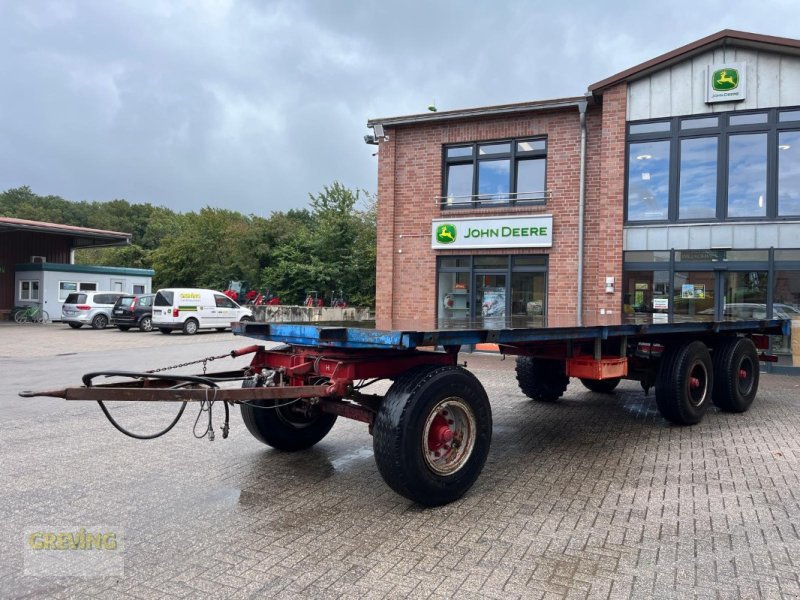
239, 379, 336, 452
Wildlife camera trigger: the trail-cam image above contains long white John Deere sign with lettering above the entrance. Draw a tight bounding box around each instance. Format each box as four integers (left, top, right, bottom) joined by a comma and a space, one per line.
431, 215, 553, 249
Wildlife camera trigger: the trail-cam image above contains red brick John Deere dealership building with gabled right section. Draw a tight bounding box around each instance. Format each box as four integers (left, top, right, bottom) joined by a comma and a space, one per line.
368, 30, 800, 364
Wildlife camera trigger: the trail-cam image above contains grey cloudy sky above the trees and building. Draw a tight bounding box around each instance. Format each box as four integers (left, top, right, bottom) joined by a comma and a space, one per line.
0, 0, 800, 216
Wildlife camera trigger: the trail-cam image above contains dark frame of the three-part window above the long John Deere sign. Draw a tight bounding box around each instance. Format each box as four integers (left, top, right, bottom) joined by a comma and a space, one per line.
439, 135, 549, 210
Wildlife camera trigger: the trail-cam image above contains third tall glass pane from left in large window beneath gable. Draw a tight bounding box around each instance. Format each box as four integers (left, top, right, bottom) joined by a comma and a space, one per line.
728, 133, 767, 217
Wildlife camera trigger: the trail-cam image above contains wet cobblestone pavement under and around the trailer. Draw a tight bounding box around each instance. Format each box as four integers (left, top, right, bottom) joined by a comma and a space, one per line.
0, 331, 800, 600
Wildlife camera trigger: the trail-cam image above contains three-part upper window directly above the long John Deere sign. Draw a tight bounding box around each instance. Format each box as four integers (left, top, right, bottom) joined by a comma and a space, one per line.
440, 138, 547, 208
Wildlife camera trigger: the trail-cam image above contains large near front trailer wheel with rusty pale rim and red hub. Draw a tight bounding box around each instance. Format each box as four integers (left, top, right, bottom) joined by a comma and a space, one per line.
373, 366, 492, 506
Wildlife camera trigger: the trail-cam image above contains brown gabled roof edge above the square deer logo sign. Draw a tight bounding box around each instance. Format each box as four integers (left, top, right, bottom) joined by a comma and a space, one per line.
589, 29, 800, 95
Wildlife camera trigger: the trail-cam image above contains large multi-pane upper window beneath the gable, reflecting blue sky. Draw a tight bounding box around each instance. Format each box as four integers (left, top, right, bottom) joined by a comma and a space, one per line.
625, 109, 800, 223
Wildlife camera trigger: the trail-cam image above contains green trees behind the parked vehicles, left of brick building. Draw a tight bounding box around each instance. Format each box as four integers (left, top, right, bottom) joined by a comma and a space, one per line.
0, 182, 376, 306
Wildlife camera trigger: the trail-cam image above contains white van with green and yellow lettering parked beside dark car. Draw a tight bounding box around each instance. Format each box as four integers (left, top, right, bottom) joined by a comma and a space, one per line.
153, 288, 253, 335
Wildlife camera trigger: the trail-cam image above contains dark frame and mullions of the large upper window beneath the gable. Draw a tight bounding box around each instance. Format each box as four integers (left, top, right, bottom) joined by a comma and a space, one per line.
623, 107, 800, 225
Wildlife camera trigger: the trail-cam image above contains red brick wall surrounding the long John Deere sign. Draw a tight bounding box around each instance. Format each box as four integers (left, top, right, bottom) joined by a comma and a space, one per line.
376, 84, 625, 325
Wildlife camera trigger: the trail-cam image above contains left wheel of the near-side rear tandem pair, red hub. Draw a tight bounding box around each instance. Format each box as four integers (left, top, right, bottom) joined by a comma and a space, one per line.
656, 341, 714, 425
